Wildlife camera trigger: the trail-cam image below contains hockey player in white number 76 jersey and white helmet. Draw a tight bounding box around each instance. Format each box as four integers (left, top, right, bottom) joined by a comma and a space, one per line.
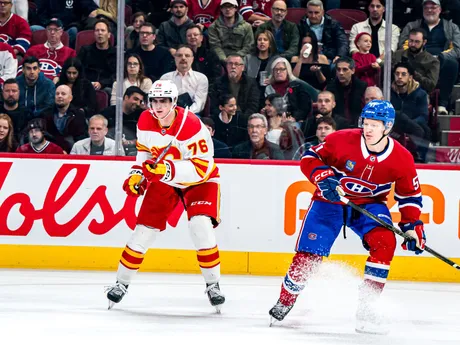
107, 80, 225, 311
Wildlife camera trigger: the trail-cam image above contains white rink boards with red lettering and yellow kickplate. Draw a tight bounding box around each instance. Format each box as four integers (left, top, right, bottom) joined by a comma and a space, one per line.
0, 155, 460, 282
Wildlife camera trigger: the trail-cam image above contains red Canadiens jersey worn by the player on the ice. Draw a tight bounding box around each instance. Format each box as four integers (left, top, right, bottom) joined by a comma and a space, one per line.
300, 129, 422, 224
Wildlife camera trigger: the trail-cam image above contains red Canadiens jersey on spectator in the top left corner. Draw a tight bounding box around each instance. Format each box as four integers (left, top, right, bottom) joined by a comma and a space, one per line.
0, 13, 32, 54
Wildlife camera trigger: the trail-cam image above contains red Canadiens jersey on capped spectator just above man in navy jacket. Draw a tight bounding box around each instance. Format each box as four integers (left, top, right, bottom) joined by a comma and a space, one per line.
22, 42, 77, 80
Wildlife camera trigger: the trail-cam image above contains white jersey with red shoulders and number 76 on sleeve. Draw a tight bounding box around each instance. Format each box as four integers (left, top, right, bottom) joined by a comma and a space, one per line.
136, 107, 219, 189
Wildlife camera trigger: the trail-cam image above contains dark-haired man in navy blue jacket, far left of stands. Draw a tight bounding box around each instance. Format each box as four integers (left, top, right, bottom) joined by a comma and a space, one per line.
16, 56, 55, 117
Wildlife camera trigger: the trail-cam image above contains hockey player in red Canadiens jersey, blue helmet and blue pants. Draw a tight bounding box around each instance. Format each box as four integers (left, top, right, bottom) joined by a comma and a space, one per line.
269, 100, 426, 333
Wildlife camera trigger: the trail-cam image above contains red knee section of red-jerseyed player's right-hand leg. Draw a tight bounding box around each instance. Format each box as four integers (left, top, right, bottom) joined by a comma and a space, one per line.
363, 227, 396, 262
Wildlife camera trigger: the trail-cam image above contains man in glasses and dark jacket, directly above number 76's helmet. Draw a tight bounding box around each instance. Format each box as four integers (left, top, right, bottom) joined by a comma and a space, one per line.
131, 23, 174, 82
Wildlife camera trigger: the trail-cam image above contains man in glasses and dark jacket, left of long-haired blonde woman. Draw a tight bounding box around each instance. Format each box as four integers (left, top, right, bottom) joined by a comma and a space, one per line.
209, 55, 259, 119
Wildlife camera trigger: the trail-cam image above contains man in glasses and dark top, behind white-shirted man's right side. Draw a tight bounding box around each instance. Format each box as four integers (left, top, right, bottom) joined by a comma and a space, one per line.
186, 24, 223, 87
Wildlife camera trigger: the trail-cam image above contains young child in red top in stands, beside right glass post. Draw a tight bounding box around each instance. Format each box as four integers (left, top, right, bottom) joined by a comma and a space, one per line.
352, 32, 380, 86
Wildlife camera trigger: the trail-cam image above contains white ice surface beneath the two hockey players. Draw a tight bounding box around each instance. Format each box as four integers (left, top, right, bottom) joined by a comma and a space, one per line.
0, 263, 460, 345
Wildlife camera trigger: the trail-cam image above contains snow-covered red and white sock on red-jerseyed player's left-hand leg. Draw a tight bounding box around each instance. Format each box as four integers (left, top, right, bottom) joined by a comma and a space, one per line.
280, 252, 323, 306
